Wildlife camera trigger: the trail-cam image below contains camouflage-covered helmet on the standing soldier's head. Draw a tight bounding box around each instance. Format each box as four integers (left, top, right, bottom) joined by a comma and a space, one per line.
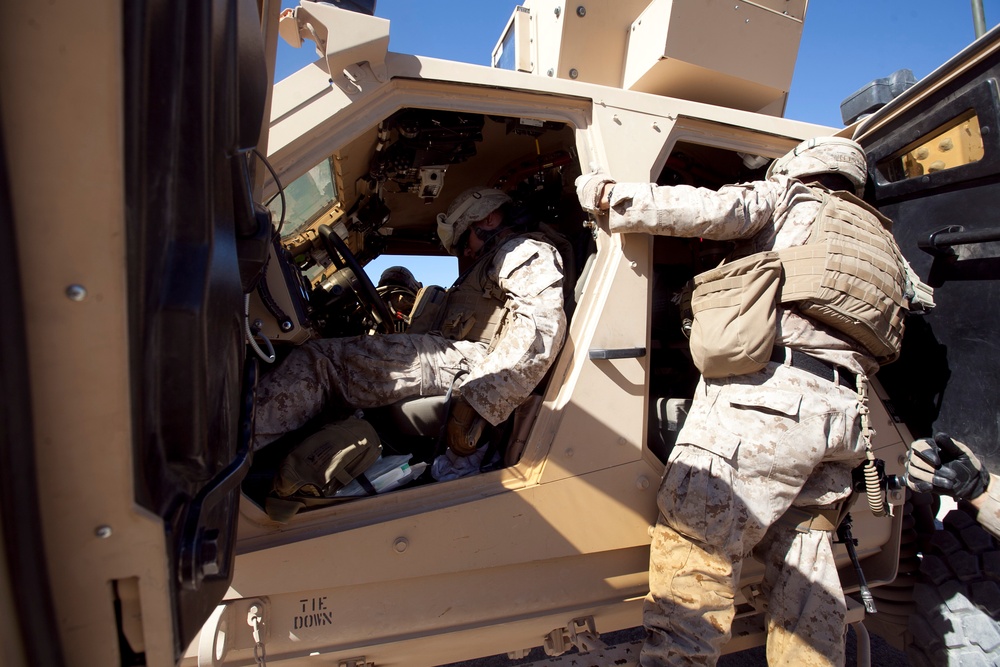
767, 137, 868, 197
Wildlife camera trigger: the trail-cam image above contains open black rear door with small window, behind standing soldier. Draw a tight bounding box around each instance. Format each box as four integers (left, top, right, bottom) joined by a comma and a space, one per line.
855, 30, 1000, 469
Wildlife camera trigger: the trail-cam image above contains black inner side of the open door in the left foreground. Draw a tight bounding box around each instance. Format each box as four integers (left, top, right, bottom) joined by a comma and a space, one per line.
124, 0, 273, 654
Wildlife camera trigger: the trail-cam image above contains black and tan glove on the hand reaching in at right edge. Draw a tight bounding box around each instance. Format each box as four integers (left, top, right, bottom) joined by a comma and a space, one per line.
906, 433, 990, 500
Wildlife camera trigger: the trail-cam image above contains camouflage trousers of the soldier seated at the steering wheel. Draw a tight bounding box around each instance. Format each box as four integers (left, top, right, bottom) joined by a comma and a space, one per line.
253, 334, 487, 449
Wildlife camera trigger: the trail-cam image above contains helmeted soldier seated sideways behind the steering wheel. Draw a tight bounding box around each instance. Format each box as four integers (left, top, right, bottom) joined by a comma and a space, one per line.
254, 187, 566, 455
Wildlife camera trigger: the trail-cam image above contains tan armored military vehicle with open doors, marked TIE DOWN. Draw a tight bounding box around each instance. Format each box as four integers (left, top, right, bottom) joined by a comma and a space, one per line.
0, 0, 1000, 667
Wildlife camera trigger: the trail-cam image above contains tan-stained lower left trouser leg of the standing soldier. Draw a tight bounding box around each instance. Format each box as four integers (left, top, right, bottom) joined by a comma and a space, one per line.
639, 517, 738, 667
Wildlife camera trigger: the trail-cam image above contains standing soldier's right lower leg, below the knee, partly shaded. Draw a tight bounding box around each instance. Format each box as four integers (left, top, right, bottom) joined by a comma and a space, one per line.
762, 523, 847, 667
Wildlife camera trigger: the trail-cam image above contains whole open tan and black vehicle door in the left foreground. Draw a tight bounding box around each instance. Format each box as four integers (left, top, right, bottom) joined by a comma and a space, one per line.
0, 0, 279, 665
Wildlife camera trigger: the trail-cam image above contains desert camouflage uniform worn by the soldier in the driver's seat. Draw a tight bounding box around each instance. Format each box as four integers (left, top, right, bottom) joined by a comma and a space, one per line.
254, 237, 566, 448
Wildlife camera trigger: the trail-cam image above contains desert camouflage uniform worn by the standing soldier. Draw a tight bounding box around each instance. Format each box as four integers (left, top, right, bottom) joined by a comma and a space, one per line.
610, 176, 877, 667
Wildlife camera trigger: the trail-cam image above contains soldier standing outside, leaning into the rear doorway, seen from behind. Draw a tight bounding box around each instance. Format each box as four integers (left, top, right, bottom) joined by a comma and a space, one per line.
577, 137, 906, 667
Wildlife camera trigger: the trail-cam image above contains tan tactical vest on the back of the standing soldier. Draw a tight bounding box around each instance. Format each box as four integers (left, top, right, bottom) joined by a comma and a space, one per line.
778, 187, 908, 364
